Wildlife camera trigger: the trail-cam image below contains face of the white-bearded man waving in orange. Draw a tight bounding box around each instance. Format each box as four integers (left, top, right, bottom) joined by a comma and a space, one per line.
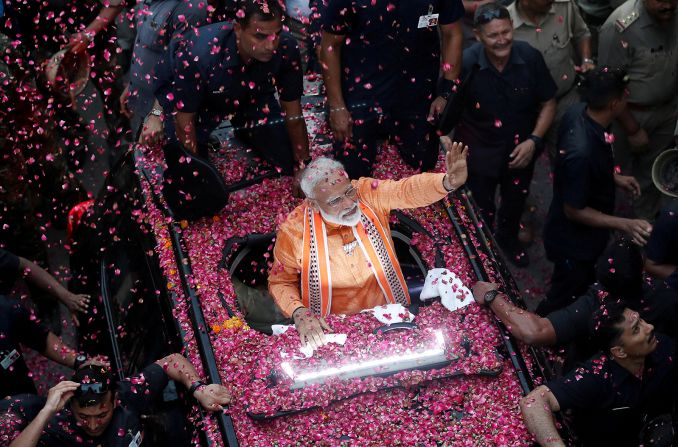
313, 170, 360, 226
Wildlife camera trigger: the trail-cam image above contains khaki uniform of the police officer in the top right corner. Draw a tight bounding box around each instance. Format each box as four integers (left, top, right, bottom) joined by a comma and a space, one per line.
598, 0, 678, 220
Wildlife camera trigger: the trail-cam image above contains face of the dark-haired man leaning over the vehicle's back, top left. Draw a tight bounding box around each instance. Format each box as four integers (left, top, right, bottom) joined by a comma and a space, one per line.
234, 15, 282, 62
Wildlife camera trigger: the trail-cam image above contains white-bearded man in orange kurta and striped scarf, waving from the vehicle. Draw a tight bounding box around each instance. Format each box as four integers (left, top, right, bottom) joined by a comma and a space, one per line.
268, 137, 468, 348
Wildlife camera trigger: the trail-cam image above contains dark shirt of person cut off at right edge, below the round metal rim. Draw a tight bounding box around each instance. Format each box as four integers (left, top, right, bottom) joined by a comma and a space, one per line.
645, 200, 678, 290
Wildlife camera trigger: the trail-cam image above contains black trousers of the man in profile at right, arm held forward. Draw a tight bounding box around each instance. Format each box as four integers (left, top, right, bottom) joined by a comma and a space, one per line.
536, 256, 596, 317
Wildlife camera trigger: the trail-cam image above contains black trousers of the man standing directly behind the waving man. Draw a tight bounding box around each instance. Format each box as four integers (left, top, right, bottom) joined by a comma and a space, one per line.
333, 107, 440, 179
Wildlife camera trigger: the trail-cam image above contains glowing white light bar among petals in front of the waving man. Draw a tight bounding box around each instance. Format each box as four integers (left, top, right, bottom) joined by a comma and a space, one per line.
280, 331, 458, 389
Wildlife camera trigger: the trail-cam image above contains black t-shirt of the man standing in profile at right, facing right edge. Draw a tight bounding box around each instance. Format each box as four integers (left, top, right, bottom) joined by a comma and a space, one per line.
544, 103, 615, 261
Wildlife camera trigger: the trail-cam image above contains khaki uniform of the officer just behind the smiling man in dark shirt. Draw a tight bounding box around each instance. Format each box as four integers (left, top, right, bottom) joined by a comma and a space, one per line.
508, 0, 591, 160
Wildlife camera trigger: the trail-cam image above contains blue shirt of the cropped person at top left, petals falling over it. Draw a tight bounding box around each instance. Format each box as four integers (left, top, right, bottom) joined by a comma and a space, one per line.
128, 0, 207, 135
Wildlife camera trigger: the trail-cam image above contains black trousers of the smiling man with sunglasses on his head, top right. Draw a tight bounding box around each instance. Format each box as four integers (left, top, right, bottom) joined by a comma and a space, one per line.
466, 160, 534, 241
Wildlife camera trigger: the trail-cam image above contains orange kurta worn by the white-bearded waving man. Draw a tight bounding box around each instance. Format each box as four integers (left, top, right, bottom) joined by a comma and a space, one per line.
268, 173, 447, 316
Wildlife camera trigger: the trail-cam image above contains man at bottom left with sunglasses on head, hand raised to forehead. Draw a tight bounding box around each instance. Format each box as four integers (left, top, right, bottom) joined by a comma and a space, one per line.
0, 354, 231, 447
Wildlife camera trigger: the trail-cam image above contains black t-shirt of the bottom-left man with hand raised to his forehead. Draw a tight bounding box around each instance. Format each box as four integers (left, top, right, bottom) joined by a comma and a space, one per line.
40, 363, 169, 447
